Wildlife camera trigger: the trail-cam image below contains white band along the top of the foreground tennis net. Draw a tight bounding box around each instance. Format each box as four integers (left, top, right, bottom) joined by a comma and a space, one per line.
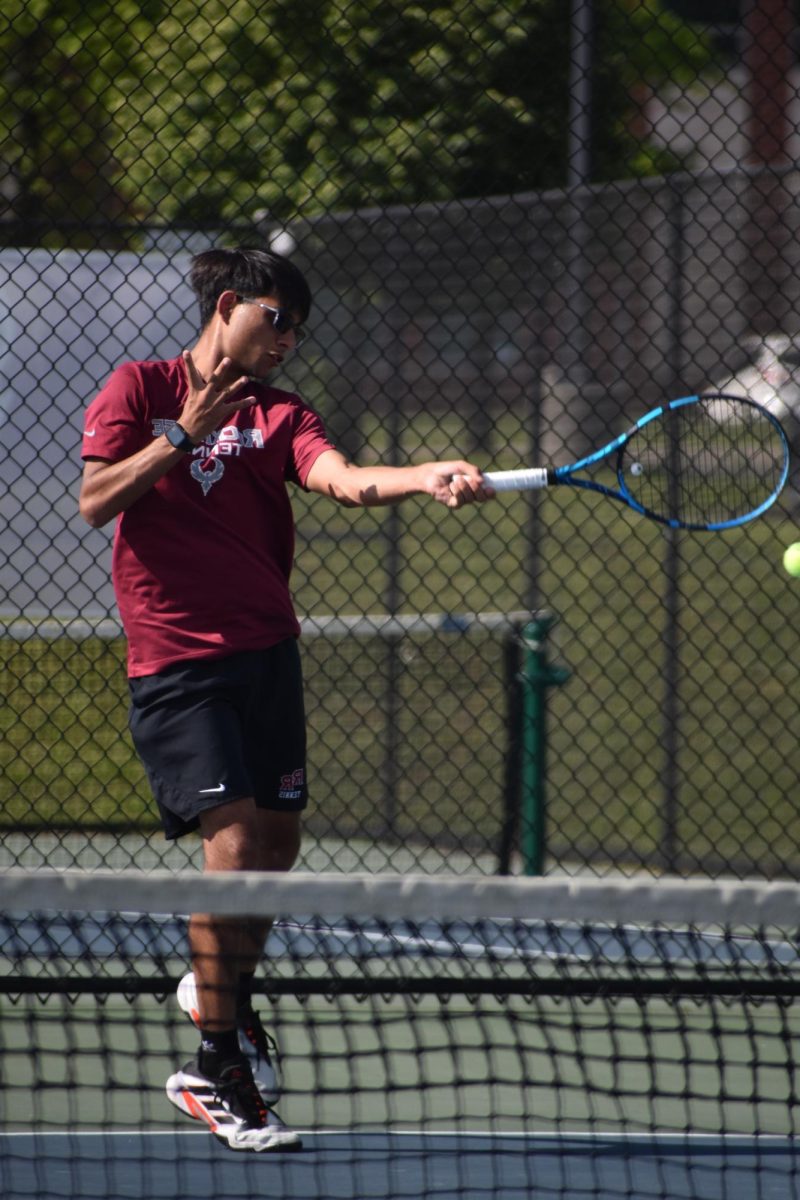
0, 868, 800, 930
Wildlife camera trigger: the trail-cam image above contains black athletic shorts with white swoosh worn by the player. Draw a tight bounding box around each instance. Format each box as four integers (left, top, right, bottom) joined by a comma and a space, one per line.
128, 638, 308, 838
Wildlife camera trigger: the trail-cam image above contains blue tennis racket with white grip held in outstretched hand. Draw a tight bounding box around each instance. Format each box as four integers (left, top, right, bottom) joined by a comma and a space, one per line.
483, 392, 789, 530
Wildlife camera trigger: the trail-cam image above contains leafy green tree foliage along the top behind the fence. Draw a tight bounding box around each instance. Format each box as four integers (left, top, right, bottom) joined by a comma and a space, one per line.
0, 0, 708, 240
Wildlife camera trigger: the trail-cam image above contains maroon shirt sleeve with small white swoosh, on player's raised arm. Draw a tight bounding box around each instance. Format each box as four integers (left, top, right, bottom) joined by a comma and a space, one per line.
80, 362, 149, 462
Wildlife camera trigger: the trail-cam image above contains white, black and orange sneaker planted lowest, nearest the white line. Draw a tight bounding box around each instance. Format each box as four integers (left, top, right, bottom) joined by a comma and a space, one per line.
167, 1055, 302, 1153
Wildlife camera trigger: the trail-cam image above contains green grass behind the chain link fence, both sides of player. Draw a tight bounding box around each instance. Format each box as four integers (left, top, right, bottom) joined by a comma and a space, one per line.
0, 480, 800, 874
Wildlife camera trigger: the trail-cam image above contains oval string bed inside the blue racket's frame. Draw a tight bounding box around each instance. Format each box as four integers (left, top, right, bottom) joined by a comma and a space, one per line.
619, 396, 786, 527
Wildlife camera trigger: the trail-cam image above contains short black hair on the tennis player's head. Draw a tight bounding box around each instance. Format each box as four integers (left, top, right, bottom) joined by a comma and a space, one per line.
190, 246, 311, 329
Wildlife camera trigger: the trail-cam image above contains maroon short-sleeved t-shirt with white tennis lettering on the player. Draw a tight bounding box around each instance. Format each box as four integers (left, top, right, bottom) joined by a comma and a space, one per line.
82, 358, 332, 676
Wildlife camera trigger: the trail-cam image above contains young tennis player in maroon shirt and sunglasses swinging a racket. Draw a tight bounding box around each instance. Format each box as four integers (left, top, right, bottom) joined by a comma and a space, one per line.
80, 248, 491, 1151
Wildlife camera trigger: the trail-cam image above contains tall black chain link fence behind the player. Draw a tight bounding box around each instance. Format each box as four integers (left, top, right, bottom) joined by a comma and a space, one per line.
0, 0, 800, 876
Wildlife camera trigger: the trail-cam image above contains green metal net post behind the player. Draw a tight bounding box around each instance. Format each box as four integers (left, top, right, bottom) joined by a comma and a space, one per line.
521, 612, 570, 875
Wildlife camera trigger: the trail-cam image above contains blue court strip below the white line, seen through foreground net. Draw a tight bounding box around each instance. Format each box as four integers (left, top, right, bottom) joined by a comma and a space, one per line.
0, 1132, 800, 1200
